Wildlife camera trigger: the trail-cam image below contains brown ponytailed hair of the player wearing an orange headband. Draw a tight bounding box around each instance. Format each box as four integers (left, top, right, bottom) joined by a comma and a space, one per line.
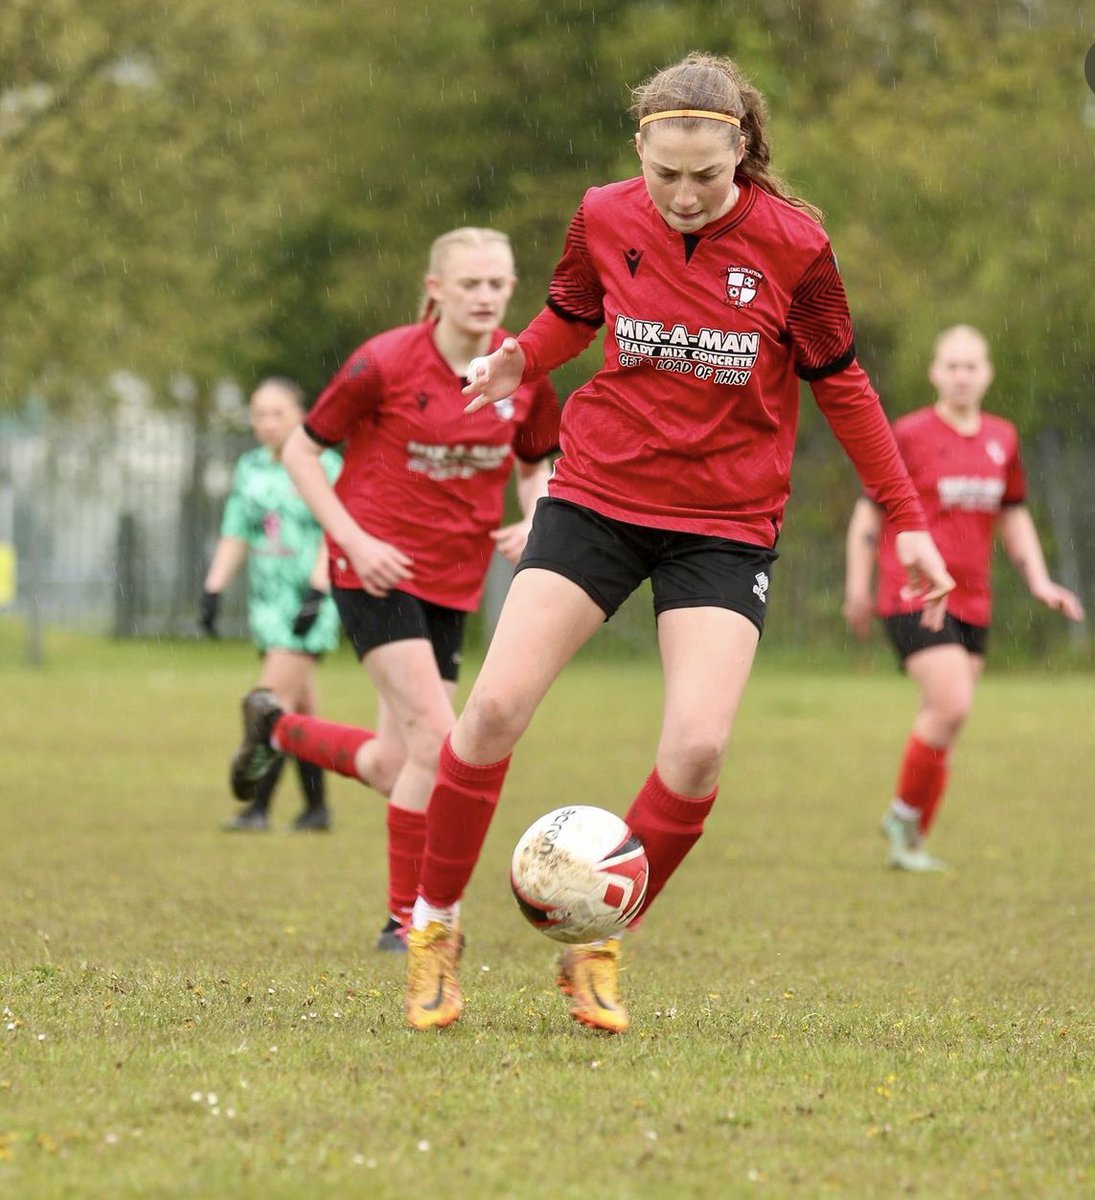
630, 52, 821, 222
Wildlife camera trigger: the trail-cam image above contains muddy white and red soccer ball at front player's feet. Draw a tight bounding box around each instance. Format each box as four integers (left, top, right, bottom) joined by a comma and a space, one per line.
509, 804, 650, 942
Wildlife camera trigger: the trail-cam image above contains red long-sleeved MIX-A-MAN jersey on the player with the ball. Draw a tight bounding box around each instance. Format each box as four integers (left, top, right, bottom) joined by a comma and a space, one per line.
520, 179, 925, 546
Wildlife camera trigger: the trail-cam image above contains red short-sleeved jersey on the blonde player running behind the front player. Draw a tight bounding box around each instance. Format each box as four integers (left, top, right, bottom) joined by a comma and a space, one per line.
305, 322, 560, 611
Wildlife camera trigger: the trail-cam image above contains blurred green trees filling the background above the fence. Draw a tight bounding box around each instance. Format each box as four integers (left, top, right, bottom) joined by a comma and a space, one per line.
0, 0, 1095, 652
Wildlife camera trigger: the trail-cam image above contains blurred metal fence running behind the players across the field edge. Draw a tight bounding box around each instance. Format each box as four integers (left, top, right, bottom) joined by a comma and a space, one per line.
0, 404, 1095, 656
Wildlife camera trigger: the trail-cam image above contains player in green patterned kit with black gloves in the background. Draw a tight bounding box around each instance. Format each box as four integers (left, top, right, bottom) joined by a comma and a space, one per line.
201, 378, 342, 830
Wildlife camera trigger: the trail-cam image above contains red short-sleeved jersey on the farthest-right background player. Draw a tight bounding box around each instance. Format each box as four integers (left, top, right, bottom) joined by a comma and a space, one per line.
876, 408, 1027, 625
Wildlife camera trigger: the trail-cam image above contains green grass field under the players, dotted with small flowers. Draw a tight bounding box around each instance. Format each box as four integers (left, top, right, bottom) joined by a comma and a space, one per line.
0, 635, 1095, 1200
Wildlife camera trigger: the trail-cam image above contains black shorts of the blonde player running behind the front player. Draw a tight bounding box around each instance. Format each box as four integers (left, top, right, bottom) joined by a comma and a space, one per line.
331, 588, 467, 683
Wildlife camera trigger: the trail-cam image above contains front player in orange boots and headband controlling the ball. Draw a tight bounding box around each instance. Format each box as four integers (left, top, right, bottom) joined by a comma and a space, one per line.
406, 54, 952, 1031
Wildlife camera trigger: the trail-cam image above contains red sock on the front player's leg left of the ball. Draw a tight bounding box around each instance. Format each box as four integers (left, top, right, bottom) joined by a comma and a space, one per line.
419, 738, 510, 908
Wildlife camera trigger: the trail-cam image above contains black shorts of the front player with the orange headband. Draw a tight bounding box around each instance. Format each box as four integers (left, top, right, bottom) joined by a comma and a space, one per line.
517, 497, 778, 632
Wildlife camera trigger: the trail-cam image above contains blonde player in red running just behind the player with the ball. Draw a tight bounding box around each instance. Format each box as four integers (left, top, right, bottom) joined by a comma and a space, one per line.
233, 228, 560, 950
